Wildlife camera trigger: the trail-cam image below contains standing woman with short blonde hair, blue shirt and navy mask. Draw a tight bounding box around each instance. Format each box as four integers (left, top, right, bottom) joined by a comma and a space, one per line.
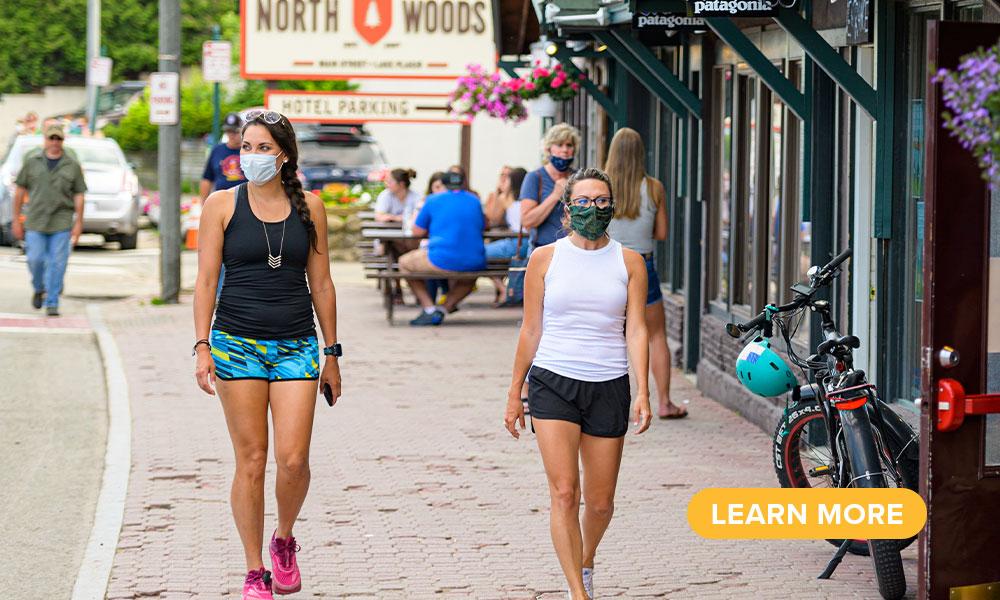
518, 123, 580, 253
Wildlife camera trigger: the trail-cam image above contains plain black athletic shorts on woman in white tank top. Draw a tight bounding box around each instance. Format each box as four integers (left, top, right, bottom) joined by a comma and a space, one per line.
528, 367, 632, 437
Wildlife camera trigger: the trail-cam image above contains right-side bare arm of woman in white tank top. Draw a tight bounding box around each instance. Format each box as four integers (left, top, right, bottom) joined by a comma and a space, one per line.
622, 249, 653, 433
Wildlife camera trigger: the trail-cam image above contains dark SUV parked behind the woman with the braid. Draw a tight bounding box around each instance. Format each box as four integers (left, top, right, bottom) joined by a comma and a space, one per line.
295, 124, 388, 192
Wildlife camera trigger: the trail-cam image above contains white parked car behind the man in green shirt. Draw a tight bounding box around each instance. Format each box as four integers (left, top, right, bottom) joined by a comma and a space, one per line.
0, 135, 140, 250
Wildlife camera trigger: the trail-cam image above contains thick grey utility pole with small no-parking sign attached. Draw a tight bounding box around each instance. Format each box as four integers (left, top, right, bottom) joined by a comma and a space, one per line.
157, 0, 181, 304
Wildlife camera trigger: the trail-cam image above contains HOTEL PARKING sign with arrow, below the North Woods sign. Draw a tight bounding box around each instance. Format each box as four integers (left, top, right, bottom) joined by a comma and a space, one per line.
264, 90, 462, 123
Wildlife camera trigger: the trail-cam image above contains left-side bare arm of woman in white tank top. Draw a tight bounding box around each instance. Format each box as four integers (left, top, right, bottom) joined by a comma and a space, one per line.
504, 246, 553, 438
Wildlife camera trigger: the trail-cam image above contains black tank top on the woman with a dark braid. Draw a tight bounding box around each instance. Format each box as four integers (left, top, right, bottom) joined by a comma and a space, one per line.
212, 183, 316, 340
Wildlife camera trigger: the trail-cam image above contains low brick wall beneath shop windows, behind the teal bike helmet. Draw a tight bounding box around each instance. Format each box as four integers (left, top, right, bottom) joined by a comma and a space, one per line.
698, 314, 805, 434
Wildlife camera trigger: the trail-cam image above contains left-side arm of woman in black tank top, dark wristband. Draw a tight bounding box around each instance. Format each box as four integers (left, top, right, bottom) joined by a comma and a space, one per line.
194, 190, 233, 395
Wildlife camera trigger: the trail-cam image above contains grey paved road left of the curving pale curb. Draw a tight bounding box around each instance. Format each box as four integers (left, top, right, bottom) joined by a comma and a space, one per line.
0, 231, 194, 599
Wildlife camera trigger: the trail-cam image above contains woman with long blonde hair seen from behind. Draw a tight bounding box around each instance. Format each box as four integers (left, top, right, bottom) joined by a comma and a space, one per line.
604, 127, 687, 419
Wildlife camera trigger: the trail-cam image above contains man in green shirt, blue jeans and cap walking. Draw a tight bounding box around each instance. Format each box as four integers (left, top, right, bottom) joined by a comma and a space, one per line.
13, 124, 87, 317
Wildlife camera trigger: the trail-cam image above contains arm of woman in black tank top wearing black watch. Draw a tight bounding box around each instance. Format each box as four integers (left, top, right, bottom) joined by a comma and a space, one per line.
305, 192, 340, 400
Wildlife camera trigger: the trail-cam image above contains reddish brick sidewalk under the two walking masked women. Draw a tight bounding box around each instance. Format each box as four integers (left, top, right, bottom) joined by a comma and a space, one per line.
104, 274, 916, 599
